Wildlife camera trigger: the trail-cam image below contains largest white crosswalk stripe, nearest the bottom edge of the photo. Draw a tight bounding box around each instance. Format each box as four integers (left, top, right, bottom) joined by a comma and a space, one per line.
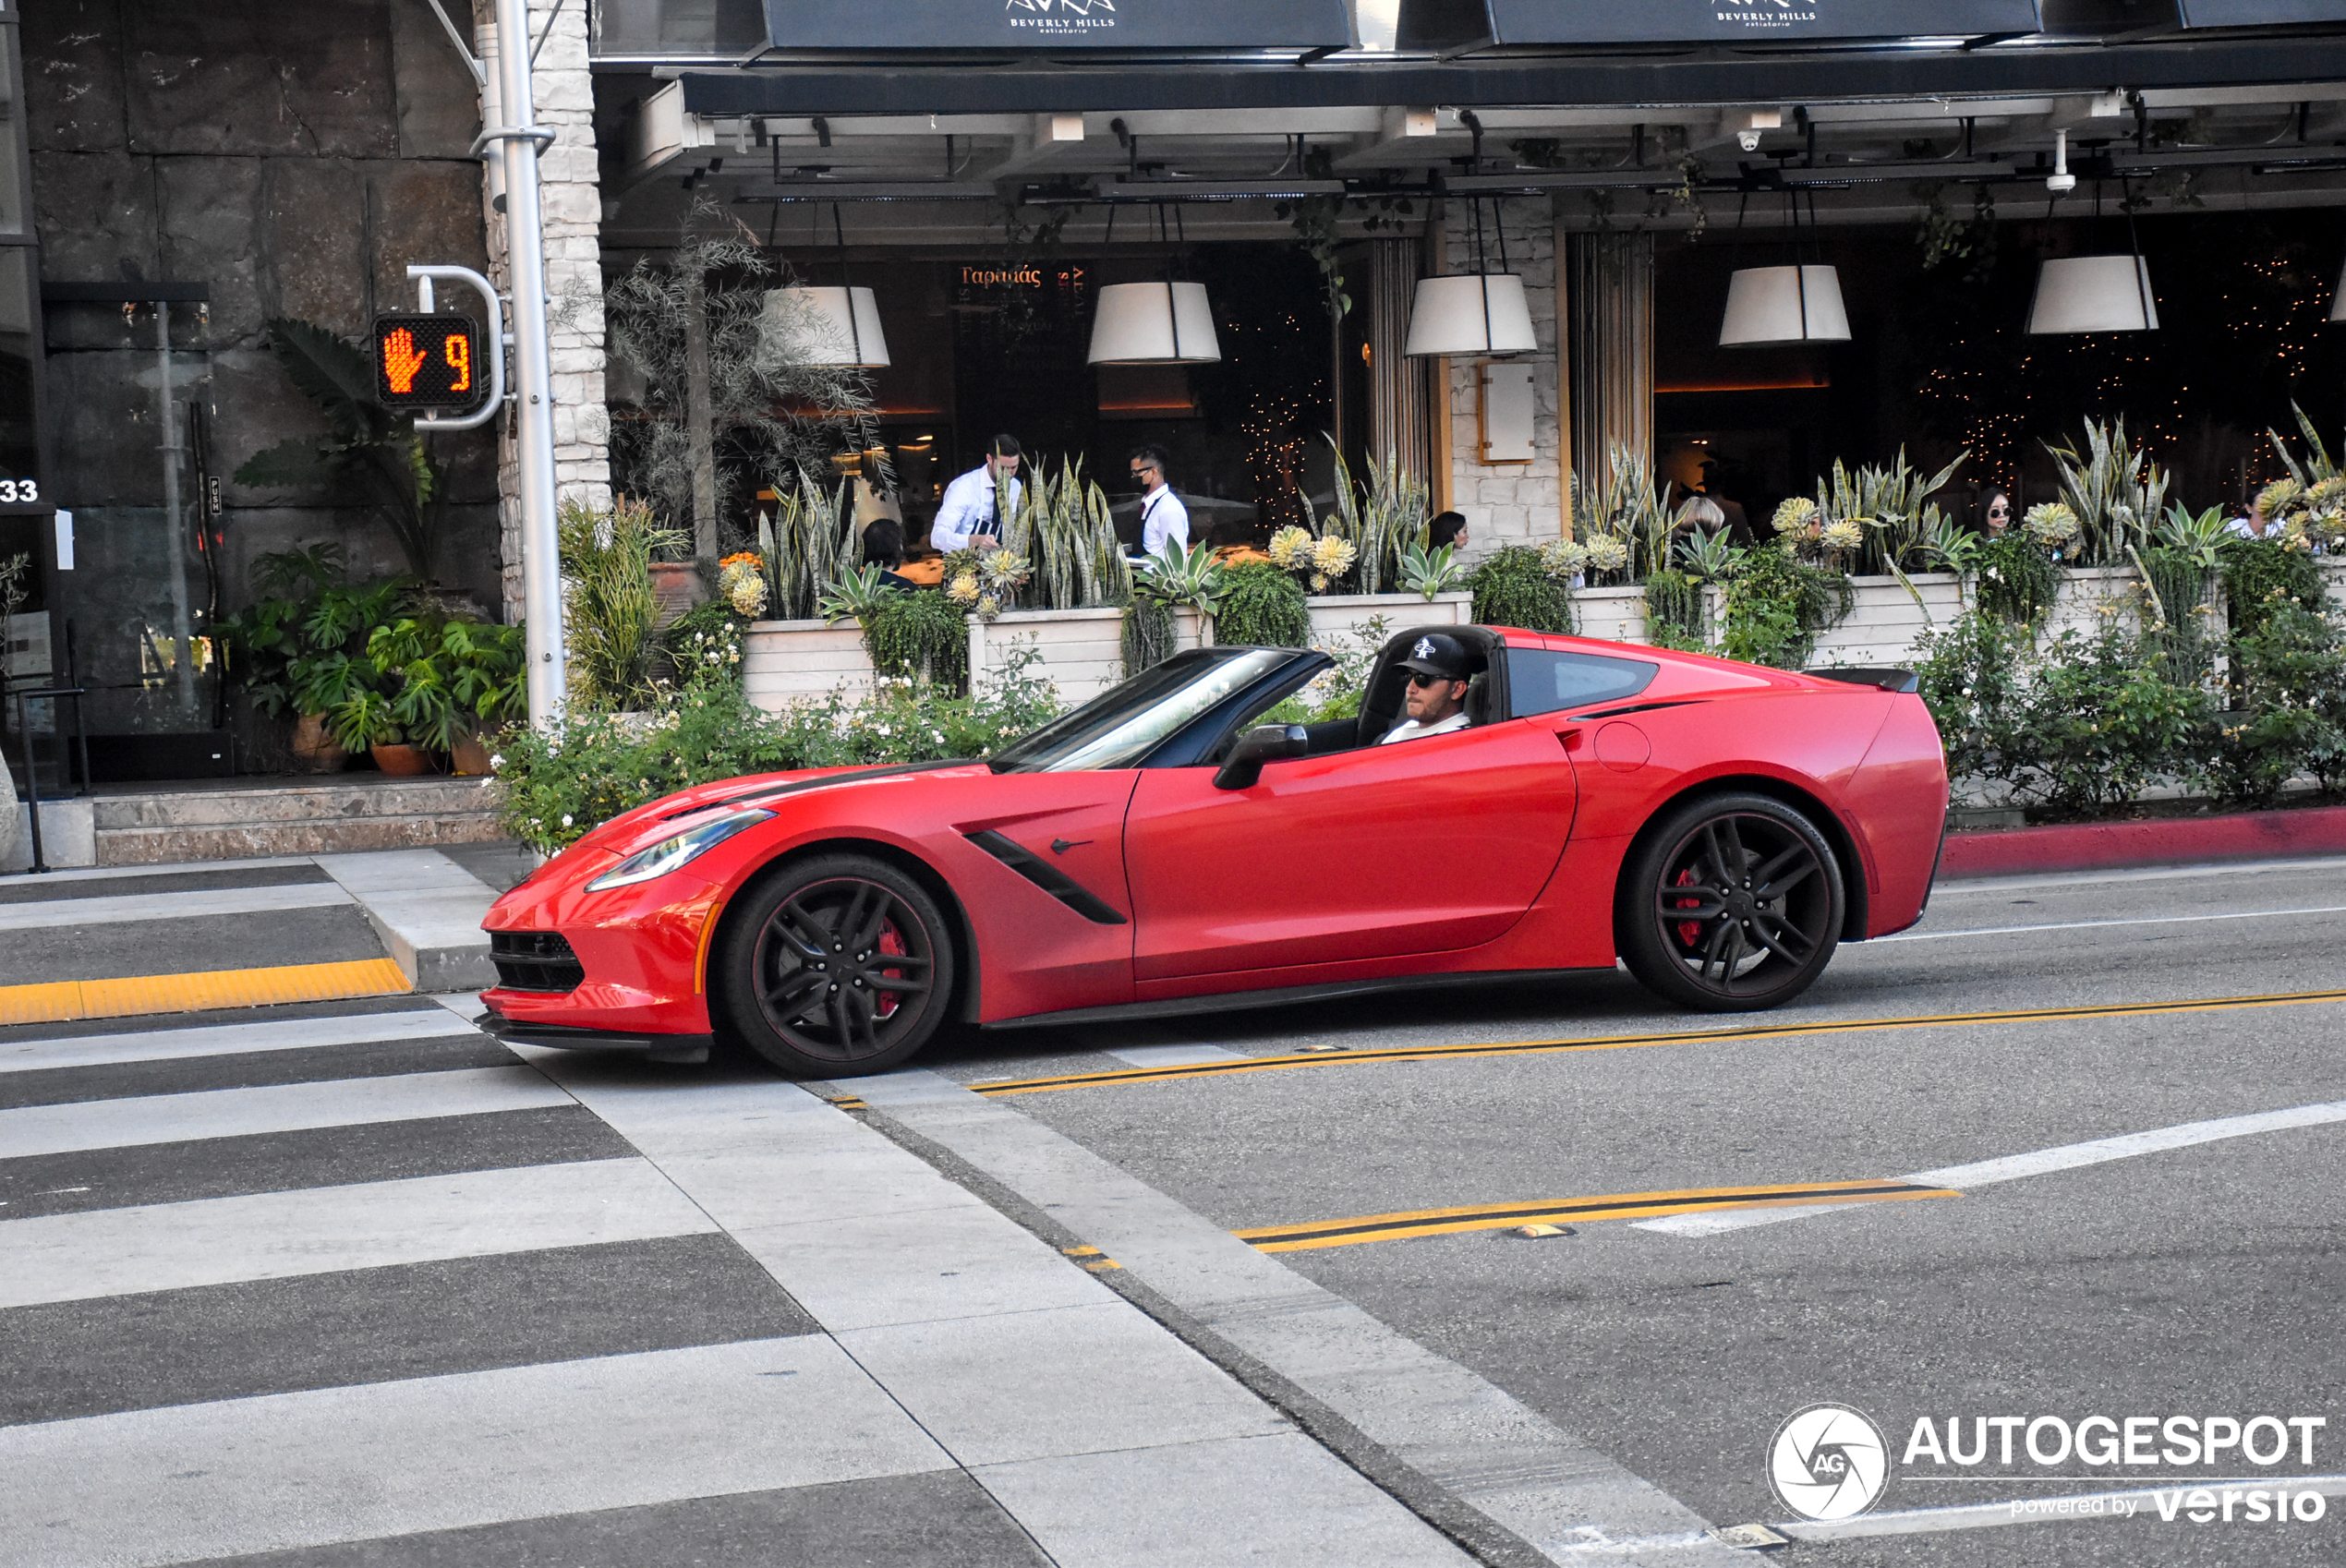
0, 1336, 952, 1568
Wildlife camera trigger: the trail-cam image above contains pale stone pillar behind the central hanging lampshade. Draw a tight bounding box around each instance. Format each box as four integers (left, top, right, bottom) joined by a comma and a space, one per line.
1445, 197, 1565, 561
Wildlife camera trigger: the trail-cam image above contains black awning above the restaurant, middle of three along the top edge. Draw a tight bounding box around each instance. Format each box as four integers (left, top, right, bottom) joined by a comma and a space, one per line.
1400, 0, 2045, 49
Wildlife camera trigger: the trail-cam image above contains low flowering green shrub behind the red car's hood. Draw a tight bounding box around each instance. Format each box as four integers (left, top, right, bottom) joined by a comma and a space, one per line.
495, 646, 1058, 853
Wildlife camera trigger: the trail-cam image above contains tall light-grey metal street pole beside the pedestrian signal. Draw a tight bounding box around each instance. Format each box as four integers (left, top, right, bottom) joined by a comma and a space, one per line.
481, 0, 570, 724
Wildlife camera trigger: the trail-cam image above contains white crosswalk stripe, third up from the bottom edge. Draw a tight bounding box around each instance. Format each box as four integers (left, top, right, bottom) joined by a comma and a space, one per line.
0, 1067, 573, 1160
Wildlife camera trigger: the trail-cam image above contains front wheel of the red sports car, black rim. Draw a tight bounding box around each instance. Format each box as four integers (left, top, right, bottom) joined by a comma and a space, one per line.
711, 855, 952, 1079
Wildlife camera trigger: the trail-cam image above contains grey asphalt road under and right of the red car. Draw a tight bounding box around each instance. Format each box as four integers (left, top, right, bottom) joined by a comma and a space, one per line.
910, 862, 2346, 1565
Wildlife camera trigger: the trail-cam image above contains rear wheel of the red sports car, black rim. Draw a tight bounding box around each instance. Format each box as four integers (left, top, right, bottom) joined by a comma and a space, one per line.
1614, 792, 1846, 1012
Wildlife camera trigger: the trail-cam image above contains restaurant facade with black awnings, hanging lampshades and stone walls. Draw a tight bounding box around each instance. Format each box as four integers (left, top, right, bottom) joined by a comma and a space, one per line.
0, 0, 2346, 778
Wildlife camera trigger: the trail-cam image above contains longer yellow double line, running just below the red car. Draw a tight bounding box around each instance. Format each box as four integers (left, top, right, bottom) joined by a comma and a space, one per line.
969, 992, 2346, 1099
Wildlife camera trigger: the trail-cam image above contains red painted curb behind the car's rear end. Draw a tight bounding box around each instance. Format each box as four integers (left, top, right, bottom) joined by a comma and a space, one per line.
1938, 806, 2346, 876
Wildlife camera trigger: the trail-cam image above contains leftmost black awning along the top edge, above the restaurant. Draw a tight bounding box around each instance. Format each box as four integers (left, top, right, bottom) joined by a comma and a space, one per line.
765, 0, 1354, 54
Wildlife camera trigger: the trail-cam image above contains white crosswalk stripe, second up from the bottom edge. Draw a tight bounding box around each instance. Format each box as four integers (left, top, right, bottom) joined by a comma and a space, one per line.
0, 1160, 718, 1312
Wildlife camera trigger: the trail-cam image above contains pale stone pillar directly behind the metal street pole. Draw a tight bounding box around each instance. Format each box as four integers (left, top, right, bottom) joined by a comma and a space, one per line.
477, 0, 610, 621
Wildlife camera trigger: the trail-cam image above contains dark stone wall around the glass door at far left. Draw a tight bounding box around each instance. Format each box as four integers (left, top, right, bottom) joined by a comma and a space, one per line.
23, 0, 500, 656
